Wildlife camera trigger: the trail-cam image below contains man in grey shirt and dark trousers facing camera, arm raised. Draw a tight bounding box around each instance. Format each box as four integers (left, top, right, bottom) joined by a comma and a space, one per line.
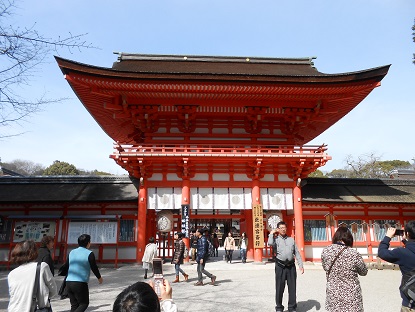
268, 221, 304, 312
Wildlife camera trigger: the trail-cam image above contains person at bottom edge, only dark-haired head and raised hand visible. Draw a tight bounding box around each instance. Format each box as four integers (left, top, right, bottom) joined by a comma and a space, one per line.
112, 280, 177, 312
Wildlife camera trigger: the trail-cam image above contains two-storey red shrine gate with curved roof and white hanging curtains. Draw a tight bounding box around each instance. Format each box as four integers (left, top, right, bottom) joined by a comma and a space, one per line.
56, 53, 389, 261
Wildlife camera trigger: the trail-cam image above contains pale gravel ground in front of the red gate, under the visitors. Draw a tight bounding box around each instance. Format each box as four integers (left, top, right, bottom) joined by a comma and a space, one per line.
0, 257, 401, 312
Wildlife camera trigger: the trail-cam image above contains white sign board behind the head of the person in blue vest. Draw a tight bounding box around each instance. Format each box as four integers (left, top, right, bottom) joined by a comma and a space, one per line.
68, 221, 118, 244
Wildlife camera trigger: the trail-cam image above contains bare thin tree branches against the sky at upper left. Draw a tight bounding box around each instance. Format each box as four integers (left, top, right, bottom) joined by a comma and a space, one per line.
0, 0, 93, 138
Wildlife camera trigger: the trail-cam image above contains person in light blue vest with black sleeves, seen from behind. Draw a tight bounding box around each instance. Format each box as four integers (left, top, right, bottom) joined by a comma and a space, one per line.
64, 234, 103, 312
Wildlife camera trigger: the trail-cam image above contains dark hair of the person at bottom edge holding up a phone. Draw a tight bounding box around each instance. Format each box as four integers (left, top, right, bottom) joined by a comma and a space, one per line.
112, 282, 160, 312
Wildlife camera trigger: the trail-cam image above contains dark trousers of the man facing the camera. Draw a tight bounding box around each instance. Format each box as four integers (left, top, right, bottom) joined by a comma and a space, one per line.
275, 264, 297, 312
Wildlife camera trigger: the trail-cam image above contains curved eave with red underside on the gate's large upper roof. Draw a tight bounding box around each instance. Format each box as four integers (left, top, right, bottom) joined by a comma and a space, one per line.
56, 57, 390, 145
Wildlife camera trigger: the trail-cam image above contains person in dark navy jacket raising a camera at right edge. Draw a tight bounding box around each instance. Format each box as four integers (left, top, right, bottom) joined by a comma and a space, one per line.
378, 221, 415, 312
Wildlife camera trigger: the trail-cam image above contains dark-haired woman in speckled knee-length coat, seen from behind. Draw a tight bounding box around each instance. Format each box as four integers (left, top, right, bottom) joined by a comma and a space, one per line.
321, 226, 367, 312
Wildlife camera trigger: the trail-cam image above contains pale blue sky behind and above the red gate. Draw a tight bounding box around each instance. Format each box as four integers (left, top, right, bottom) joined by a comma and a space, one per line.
0, 0, 415, 174
